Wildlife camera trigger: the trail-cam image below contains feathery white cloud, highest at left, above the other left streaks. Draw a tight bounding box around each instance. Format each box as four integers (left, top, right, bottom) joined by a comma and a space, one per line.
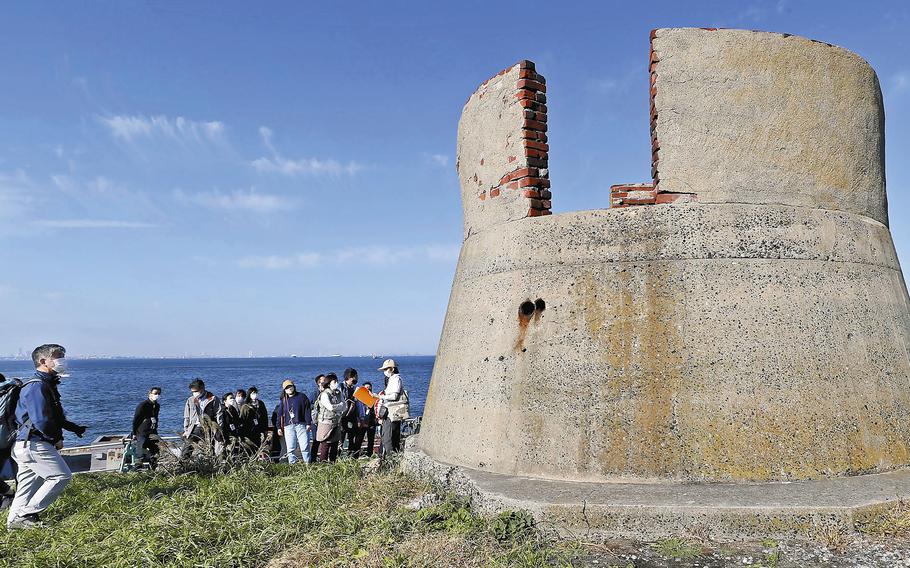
97, 114, 226, 144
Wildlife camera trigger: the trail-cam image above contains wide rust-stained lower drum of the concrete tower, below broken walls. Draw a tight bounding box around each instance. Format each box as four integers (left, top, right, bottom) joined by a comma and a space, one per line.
420, 204, 910, 480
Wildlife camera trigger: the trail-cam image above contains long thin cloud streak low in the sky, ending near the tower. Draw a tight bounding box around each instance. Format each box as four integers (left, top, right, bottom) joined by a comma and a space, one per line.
237, 245, 459, 270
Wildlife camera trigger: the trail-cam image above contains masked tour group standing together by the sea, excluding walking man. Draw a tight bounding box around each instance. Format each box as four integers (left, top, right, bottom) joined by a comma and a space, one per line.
168, 359, 407, 464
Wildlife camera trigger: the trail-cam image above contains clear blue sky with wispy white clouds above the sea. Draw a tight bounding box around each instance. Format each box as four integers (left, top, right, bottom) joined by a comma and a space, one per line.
0, 0, 910, 355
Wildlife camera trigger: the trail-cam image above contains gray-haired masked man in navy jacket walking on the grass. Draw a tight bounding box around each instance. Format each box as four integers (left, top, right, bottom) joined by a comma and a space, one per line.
6, 343, 86, 530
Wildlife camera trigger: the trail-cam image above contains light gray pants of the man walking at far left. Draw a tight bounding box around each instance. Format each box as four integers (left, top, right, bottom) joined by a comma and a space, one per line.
6, 440, 73, 524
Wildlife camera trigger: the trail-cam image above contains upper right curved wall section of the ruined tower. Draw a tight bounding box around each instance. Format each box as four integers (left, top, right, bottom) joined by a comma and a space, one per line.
651, 29, 888, 224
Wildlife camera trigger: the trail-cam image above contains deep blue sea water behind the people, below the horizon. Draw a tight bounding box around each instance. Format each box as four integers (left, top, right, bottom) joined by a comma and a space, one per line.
0, 356, 435, 446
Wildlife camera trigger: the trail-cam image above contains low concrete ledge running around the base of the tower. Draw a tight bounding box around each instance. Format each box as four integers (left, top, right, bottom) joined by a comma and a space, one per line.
402, 444, 910, 540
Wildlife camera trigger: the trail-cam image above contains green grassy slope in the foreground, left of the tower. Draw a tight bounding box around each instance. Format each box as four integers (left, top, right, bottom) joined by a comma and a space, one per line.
0, 461, 573, 568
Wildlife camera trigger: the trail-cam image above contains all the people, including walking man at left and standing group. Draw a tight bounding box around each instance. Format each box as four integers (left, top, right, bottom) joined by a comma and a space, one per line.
0, 344, 409, 529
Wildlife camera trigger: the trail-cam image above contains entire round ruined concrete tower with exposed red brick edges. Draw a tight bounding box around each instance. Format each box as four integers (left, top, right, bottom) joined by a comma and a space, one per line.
418, 25, 910, 496
